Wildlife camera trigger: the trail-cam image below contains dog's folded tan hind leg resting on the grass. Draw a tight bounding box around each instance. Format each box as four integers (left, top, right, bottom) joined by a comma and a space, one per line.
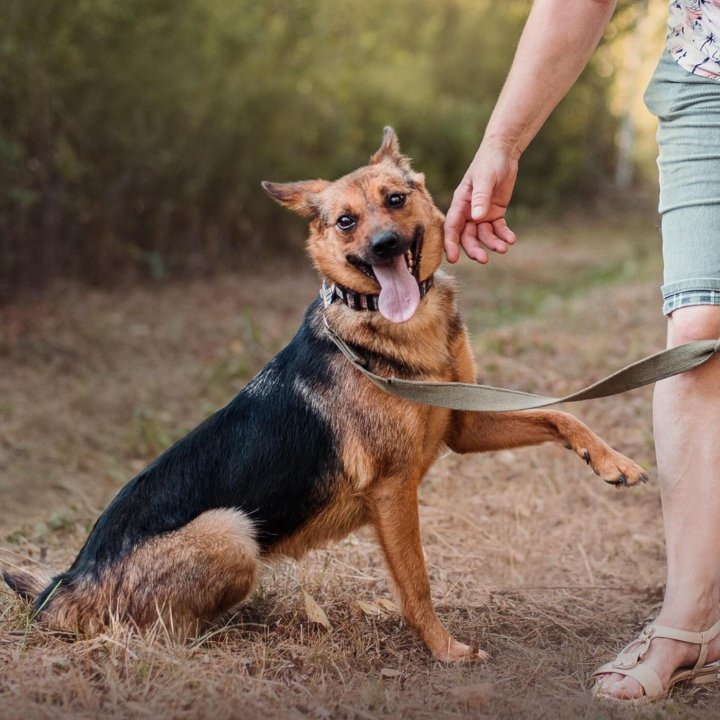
21, 509, 258, 639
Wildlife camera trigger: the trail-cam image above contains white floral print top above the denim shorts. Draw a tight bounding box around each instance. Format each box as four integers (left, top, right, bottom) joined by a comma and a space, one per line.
667, 0, 720, 81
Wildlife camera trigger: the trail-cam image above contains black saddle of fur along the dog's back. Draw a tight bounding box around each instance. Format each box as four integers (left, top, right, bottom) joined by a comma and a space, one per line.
35, 301, 339, 610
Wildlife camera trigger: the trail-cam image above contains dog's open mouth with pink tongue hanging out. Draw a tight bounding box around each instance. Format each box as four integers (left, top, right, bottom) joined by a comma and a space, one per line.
348, 226, 423, 323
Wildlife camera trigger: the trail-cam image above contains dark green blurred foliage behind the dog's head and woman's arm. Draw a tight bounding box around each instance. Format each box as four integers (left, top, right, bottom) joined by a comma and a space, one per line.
0, 0, 628, 293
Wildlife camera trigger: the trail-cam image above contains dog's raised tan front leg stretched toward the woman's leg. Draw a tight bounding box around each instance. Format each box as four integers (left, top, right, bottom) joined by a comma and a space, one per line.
446, 410, 648, 485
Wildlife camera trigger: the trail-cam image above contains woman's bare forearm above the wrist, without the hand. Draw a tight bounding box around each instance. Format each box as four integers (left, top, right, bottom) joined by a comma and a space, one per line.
484, 0, 615, 158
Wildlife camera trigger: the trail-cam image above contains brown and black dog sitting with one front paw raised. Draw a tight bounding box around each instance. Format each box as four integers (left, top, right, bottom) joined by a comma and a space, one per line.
5, 128, 646, 661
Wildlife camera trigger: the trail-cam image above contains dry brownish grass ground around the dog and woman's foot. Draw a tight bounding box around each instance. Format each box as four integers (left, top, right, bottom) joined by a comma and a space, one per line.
0, 217, 720, 720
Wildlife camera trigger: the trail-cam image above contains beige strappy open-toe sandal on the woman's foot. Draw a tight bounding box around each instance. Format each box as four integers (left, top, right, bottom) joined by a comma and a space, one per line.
592, 618, 720, 703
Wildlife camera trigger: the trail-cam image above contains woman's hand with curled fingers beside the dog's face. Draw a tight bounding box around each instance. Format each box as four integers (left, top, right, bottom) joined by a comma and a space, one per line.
445, 141, 518, 265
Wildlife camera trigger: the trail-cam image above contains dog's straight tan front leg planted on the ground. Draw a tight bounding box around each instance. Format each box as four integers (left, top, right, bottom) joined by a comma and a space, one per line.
370, 478, 487, 662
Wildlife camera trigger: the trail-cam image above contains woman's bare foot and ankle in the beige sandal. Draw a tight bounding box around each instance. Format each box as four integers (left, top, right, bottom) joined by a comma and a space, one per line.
595, 610, 720, 700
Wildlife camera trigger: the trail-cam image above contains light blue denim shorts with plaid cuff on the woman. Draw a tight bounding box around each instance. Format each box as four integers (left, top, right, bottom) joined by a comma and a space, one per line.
644, 51, 720, 315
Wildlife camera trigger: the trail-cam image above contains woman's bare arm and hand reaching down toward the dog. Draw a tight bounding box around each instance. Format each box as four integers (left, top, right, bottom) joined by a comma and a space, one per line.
445, 0, 615, 263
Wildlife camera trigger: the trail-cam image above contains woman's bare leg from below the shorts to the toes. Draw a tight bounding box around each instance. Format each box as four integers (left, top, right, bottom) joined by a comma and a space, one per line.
602, 305, 720, 698
